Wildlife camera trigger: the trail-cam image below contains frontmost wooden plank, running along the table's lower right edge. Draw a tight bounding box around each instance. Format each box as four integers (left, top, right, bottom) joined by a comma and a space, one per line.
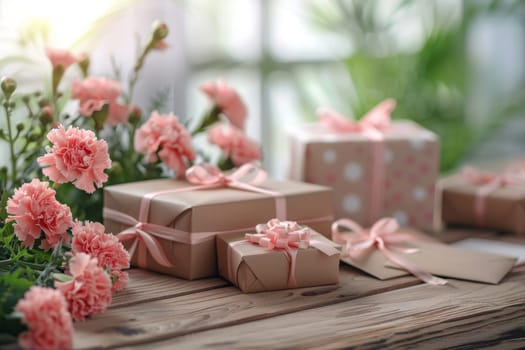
145, 267, 525, 350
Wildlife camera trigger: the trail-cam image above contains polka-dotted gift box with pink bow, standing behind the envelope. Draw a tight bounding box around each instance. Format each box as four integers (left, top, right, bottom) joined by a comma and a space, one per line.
289, 100, 439, 229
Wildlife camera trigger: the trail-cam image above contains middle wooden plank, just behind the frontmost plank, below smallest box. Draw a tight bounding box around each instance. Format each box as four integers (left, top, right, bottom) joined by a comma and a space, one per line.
74, 265, 419, 349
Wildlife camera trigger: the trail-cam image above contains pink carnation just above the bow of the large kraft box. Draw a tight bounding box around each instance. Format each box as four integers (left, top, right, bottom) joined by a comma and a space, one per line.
208, 124, 261, 167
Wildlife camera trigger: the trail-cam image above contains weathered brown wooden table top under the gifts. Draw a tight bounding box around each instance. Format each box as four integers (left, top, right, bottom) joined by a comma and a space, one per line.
74, 231, 525, 349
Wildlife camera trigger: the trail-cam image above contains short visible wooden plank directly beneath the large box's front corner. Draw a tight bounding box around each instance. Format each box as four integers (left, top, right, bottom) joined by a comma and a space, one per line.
110, 269, 229, 308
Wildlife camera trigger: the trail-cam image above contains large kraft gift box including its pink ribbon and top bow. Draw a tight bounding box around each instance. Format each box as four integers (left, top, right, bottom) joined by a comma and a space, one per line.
104, 164, 333, 279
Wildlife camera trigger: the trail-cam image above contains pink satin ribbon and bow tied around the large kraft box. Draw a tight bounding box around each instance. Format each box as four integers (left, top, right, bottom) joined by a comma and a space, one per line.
110, 163, 286, 268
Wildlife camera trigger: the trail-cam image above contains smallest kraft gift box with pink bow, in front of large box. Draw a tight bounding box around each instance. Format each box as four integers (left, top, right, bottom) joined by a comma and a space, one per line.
217, 219, 340, 293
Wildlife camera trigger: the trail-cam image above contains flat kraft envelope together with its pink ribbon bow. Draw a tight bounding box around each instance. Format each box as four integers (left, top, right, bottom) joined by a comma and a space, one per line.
332, 218, 517, 285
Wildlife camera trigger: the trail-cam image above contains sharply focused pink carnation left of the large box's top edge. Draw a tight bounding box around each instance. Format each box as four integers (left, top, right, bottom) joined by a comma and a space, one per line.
37, 125, 111, 193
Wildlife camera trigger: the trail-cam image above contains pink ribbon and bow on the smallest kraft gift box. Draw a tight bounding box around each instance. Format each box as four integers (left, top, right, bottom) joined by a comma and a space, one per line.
227, 219, 339, 288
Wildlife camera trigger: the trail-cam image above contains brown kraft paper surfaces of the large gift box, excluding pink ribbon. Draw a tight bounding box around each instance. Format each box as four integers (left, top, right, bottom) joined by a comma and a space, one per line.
104, 179, 333, 279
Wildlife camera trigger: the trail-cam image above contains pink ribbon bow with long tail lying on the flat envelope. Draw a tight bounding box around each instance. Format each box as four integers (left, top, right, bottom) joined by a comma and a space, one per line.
332, 218, 447, 285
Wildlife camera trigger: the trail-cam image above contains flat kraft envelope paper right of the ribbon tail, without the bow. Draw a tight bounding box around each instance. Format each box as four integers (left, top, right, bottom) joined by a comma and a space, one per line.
385, 242, 517, 284
